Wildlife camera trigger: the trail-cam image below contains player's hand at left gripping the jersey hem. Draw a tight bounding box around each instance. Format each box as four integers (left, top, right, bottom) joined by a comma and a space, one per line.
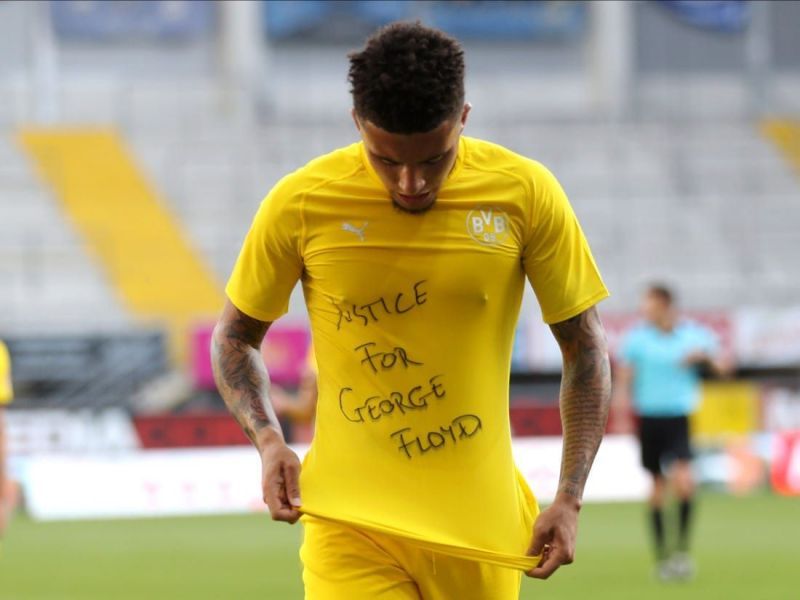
261, 439, 301, 523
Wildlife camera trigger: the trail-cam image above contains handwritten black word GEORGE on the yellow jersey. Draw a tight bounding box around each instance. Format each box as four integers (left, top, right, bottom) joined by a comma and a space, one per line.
339, 375, 447, 423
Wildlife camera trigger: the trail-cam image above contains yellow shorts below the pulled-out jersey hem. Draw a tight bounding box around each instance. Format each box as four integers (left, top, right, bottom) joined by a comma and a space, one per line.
300, 515, 522, 600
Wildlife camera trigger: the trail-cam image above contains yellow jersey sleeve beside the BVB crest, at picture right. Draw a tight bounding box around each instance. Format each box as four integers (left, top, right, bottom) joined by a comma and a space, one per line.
522, 163, 608, 324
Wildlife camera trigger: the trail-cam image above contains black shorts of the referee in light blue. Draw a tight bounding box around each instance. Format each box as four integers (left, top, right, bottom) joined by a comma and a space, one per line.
639, 415, 692, 475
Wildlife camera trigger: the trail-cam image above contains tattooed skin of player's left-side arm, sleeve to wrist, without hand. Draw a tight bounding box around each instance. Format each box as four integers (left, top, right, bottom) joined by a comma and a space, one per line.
211, 311, 277, 443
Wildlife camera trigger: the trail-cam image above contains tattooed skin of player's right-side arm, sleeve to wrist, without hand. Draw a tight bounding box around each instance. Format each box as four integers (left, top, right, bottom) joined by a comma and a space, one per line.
551, 307, 611, 499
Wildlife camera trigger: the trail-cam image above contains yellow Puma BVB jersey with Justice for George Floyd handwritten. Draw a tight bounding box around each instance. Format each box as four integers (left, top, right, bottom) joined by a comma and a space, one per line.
226, 137, 608, 569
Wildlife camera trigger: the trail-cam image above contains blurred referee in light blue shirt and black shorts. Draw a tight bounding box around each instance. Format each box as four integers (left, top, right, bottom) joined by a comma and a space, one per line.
614, 285, 730, 580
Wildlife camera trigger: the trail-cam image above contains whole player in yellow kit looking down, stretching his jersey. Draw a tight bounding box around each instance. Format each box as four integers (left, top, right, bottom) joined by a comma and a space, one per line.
212, 23, 610, 600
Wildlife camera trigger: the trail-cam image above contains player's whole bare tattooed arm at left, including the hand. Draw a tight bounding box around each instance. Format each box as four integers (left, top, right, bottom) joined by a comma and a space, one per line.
211, 301, 300, 523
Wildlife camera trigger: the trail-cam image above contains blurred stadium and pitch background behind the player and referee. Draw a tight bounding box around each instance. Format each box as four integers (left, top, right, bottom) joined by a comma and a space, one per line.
0, 0, 800, 599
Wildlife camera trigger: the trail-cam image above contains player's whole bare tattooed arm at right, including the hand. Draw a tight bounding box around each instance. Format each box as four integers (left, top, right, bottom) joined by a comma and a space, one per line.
528, 307, 611, 579
